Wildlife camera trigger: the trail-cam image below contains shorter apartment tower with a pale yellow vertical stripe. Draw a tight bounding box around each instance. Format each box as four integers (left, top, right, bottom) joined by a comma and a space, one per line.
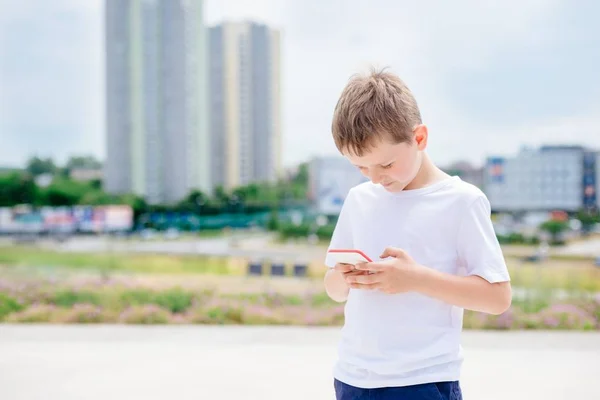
209, 22, 281, 188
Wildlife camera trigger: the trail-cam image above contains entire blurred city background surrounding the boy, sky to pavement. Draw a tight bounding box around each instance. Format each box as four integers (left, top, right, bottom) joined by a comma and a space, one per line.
0, 0, 600, 399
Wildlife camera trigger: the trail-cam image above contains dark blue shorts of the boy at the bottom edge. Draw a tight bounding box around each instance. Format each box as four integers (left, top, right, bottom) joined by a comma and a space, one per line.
334, 379, 462, 400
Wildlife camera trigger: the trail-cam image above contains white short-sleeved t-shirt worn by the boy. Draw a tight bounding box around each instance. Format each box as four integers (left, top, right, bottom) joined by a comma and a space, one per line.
325, 177, 510, 388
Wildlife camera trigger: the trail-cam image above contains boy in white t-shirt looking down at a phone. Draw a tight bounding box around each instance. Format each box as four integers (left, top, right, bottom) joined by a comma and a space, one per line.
325, 72, 511, 400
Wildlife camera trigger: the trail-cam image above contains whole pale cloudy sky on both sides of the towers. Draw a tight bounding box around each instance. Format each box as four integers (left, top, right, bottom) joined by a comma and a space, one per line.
0, 0, 600, 166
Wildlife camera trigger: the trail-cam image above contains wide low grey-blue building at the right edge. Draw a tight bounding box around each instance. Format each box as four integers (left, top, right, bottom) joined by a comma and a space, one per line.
484, 146, 600, 212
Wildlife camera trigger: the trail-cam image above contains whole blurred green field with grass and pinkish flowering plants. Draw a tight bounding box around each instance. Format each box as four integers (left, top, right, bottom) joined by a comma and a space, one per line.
0, 246, 600, 329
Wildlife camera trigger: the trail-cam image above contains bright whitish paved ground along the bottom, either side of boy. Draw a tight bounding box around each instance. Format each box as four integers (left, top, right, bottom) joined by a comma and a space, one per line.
0, 325, 600, 400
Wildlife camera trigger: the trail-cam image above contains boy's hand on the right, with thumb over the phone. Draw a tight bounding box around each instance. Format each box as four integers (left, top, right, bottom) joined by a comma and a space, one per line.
345, 247, 425, 294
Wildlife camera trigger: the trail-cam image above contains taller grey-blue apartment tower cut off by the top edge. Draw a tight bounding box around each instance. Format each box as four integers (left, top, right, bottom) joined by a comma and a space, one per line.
105, 0, 212, 203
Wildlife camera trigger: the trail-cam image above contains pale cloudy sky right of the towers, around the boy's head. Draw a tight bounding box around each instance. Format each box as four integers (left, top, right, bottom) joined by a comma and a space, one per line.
276, 0, 600, 163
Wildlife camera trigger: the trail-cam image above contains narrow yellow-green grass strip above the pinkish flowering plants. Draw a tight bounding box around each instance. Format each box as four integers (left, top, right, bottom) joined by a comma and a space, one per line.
0, 246, 600, 292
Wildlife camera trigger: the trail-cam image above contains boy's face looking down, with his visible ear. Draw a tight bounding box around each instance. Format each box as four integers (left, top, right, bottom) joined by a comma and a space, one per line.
343, 125, 427, 193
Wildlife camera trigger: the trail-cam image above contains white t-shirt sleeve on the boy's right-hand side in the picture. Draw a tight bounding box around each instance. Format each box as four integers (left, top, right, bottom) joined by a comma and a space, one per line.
458, 194, 510, 283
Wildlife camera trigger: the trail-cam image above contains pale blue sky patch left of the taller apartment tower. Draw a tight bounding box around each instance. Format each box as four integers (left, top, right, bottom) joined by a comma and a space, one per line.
0, 0, 104, 164
